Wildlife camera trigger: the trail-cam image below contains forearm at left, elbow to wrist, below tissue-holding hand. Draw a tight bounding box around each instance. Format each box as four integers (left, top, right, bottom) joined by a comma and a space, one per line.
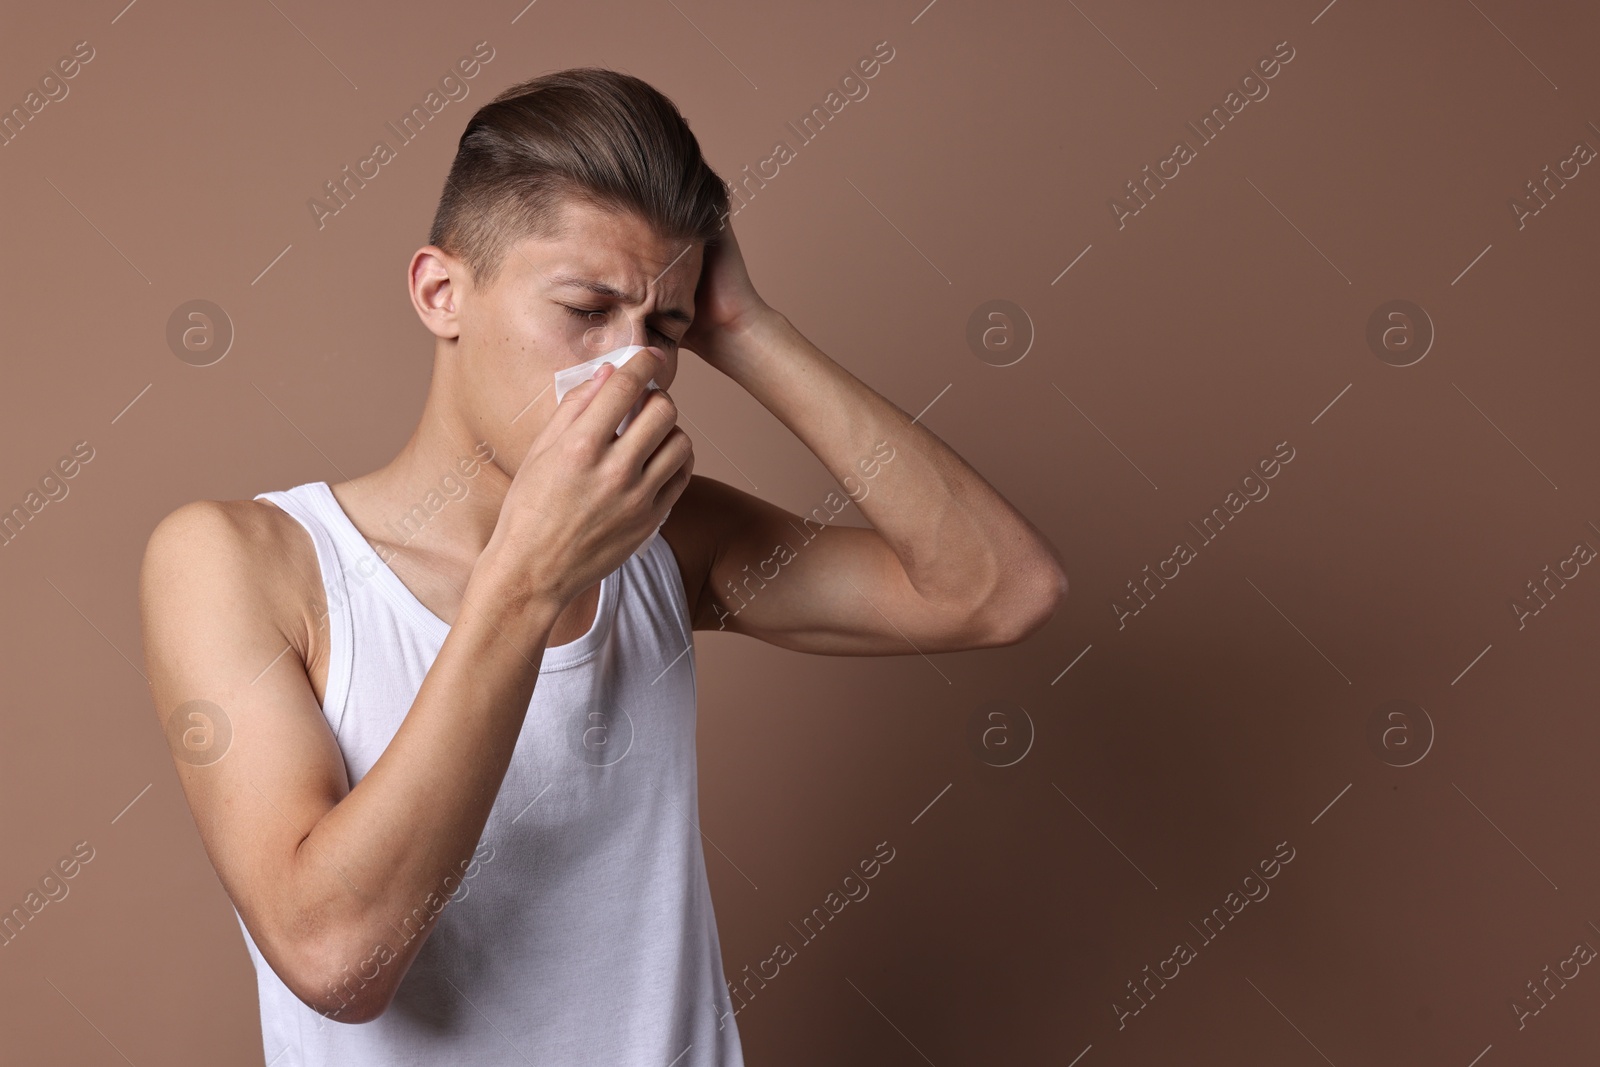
293, 568, 560, 1021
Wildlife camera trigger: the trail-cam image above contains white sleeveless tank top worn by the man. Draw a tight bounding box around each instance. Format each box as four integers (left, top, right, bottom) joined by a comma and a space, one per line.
234, 482, 744, 1067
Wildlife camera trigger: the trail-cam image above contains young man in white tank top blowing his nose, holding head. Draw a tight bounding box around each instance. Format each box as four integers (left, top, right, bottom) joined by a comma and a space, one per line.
141, 69, 1066, 1067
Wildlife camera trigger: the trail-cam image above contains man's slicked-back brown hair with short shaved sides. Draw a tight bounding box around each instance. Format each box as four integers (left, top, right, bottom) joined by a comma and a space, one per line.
427, 67, 728, 286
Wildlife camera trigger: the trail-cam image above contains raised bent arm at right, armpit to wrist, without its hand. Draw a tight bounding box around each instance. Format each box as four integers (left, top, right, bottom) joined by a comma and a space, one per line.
681, 308, 1067, 656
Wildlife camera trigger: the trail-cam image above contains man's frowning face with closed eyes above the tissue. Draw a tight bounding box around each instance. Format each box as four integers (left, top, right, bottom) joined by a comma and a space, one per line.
456, 202, 704, 462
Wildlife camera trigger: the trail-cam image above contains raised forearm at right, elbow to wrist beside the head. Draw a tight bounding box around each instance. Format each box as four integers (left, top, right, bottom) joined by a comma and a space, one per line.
709, 303, 1059, 605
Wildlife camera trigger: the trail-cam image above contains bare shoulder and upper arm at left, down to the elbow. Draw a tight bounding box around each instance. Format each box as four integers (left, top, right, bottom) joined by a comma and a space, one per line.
139, 501, 350, 1006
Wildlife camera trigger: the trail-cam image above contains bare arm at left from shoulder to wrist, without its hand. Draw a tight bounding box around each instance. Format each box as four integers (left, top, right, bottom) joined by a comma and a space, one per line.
141, 501, 560, 1022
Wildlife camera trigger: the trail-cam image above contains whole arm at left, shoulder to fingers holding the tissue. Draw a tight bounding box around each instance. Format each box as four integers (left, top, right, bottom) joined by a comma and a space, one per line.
139, 352, 693, 1022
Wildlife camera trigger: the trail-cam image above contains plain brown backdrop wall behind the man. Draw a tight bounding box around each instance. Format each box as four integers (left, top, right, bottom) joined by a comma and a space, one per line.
0, 0, 1600, 1067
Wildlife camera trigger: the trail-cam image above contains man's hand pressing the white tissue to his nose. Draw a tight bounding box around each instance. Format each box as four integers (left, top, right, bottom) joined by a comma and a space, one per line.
480, 349, 694, 611
